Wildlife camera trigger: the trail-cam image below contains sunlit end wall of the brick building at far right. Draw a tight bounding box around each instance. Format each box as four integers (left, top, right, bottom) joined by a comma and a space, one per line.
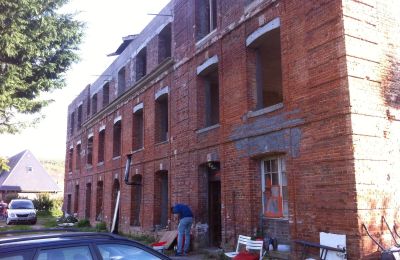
343, 1, 400, 259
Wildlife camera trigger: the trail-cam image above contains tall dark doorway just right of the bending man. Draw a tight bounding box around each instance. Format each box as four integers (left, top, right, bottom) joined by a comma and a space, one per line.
207, 162, 222, 247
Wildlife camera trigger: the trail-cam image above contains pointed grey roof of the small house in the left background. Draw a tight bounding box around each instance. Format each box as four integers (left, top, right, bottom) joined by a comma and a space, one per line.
0, 150, 61, 192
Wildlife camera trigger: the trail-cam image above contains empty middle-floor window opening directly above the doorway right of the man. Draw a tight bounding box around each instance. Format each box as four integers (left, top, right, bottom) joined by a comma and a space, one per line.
203, 70, 219, 127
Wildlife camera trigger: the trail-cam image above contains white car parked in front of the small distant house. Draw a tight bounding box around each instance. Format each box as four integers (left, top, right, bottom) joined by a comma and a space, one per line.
6, 199, 37, 225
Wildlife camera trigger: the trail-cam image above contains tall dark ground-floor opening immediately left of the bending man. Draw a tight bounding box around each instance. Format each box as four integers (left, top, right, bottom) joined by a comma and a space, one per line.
154, 171, 169, 228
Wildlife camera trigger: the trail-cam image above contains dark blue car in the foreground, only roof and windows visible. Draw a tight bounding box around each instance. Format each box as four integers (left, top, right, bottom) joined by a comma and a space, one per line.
0, 229, 171, 260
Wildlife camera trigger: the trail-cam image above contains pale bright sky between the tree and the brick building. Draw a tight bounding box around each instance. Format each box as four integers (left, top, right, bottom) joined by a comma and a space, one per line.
0, 0, 169, 159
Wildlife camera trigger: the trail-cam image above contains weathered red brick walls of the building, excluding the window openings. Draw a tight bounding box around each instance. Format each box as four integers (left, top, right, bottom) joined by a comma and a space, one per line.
65, 0, 400, 259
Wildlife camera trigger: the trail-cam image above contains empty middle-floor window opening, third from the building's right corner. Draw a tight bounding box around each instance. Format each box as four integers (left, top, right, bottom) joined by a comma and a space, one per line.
155, 94, 168, 143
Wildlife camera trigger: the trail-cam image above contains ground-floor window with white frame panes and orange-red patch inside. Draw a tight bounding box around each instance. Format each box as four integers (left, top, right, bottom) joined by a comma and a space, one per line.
261, 157, 289, 218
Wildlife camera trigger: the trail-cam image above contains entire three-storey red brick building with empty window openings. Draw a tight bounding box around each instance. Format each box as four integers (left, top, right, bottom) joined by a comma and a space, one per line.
64, 0, 400, 259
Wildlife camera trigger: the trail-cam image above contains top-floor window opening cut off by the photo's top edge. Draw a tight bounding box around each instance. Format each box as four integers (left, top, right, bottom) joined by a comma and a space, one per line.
196, 0, 217, 40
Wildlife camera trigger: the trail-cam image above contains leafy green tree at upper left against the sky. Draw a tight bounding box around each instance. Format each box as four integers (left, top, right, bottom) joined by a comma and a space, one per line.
0, 0, 83, 169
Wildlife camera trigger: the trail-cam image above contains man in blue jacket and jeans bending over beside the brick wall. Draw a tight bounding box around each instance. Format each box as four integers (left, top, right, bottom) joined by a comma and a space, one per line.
171, 204, 193, 256
